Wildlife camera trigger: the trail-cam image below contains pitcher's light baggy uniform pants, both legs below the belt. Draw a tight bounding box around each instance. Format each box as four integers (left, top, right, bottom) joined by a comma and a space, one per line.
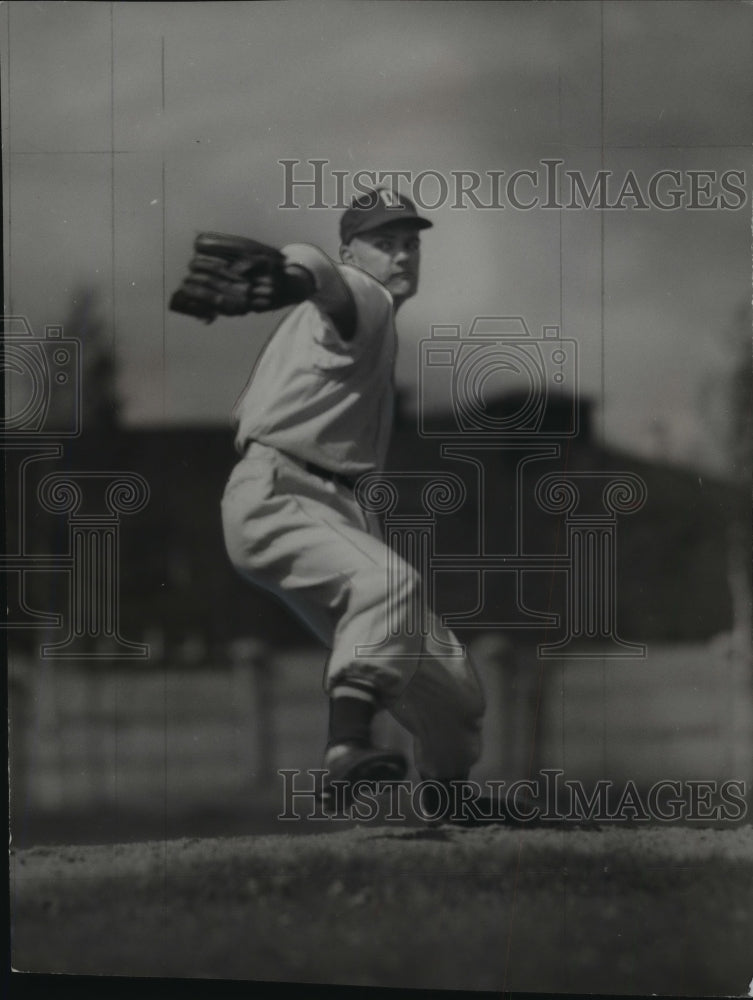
222, 441, 484, 779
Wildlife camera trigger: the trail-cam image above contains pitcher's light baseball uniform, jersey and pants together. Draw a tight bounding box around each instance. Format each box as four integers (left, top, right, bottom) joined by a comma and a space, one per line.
222, 254, 484, 779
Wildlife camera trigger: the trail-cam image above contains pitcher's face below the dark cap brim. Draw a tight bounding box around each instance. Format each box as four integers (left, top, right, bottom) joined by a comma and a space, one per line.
342, 222, 421, 307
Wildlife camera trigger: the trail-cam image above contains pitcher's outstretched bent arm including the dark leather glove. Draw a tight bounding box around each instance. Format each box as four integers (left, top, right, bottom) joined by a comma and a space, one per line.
170, 233, 356, 340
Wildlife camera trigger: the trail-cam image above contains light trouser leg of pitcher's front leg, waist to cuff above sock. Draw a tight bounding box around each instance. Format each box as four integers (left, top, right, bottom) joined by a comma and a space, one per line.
222, 445, 422, 702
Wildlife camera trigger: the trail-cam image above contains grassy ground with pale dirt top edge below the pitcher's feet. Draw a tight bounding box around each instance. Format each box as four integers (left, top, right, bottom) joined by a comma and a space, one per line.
11, 826, 753, 995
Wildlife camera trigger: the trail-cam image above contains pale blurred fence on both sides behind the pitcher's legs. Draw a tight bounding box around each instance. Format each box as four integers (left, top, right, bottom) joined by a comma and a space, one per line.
10, 633, 753, 836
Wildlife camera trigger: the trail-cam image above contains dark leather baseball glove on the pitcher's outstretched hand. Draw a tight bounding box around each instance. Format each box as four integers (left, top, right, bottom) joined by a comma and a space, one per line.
170, 233, 311, 323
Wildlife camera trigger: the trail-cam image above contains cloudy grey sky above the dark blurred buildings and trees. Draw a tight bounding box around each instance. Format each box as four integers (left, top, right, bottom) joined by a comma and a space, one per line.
0, 0, 753, 471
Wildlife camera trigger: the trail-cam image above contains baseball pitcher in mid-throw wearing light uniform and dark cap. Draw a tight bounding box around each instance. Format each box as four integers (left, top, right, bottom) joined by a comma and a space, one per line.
171, 189, 484, 816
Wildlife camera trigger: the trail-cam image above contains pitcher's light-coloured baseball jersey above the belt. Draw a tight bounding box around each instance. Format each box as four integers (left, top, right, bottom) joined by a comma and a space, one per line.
233, 264, 396, 475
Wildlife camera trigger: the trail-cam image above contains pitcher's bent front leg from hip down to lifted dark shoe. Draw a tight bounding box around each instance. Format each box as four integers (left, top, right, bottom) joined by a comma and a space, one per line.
222, 446, 424, 796
